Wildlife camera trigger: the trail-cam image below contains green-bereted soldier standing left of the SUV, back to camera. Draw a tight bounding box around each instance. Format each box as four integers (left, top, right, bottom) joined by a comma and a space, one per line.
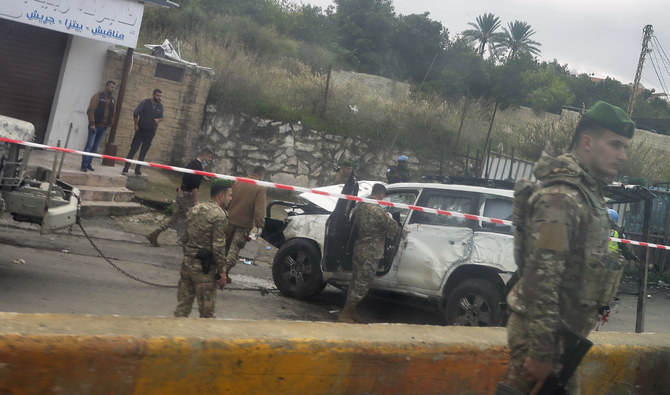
174, 178, 232, 318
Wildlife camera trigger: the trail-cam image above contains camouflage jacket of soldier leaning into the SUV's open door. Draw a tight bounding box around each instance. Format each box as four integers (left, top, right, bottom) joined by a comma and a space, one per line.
354, 203, 400, 259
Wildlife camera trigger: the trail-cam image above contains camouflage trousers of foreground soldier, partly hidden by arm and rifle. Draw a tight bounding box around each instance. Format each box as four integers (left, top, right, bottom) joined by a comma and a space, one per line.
503, 312, 579, 394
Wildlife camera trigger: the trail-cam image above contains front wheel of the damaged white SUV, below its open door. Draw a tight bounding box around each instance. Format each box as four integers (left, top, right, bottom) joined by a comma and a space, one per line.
272, 240, 326, 299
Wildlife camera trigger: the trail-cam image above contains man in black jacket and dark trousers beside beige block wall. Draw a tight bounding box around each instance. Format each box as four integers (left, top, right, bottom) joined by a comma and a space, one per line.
121, 89, 164, 176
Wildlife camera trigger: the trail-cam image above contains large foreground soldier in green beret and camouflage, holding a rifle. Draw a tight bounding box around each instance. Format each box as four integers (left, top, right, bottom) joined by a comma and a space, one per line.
496, 102, 635, 394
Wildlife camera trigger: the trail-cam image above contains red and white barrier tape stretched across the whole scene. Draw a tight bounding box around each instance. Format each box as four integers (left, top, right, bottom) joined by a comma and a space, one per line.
0, 137, 670, 250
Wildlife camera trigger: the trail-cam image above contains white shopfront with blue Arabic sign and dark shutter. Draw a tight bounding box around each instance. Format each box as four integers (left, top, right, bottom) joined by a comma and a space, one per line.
0, 0, 175, 148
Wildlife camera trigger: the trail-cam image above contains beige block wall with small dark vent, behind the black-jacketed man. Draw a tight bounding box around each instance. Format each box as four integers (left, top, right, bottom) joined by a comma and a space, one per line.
105, 49, 214, 165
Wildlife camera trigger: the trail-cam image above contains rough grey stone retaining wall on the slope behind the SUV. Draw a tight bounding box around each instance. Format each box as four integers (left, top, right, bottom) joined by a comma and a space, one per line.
200, 106, 439, 188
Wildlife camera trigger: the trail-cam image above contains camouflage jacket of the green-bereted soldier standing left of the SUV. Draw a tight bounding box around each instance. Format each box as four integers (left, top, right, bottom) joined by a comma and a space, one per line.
182, 201, 229, 273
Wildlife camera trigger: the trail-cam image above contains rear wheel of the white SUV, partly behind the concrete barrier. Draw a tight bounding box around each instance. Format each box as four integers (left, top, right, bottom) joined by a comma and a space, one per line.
446, 279, 503, 326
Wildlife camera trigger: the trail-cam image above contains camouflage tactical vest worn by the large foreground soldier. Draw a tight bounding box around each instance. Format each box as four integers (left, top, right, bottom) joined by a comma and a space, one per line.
513, 177, 623, 306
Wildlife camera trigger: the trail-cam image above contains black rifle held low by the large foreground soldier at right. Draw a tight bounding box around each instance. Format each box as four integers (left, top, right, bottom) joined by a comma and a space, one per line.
539, 324, 593, 395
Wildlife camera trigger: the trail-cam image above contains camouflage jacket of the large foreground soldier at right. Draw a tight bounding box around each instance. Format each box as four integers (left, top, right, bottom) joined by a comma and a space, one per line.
508, 152, 620, 361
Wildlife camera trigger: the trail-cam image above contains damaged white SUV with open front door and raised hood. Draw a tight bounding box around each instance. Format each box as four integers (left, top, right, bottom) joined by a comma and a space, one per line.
263, 177, 516, 326
